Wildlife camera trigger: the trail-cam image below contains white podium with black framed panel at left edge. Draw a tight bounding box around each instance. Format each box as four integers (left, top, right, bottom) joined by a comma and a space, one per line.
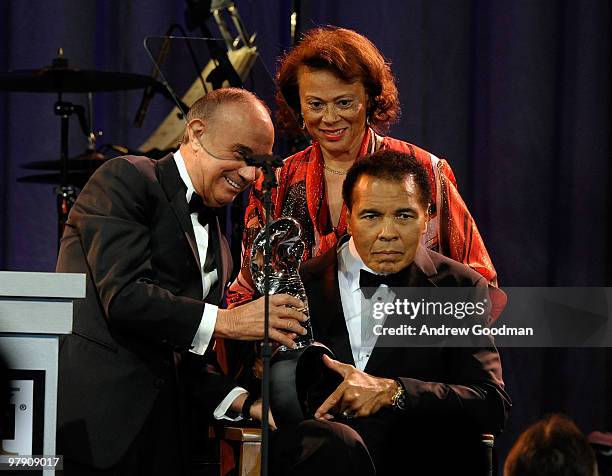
0, 271, 85, 476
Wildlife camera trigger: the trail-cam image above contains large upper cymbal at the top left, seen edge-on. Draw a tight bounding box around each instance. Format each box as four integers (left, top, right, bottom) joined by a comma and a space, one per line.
0, 67, 159, 93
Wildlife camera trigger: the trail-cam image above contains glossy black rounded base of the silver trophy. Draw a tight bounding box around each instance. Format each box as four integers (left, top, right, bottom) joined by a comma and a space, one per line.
270, 342, 342, 428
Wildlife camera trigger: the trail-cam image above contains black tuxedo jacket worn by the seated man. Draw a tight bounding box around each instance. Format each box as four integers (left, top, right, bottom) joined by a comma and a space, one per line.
301, 246, 511, 433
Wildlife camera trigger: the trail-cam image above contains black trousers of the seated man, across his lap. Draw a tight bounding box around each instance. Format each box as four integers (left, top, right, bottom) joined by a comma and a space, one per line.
270, 410, 486, 476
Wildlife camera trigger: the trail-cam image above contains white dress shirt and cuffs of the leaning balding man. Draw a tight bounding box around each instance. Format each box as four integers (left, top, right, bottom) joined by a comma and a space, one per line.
174, 150, 248, 421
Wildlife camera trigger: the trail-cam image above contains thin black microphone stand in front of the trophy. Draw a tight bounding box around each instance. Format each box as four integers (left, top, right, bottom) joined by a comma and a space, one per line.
246, 155, 283, 476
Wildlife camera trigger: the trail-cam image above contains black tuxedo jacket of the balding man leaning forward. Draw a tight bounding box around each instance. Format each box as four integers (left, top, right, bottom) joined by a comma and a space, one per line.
57, 155, 235, 467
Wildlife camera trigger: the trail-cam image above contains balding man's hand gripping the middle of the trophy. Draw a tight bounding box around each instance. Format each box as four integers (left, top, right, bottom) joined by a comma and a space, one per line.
214, 294, 308, 349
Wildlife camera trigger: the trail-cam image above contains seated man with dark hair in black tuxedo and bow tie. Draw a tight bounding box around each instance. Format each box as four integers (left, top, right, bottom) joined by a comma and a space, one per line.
273, 151, 511, 475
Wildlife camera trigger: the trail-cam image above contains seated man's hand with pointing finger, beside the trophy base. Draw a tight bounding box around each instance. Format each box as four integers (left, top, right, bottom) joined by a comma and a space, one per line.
314, 355, 397, 420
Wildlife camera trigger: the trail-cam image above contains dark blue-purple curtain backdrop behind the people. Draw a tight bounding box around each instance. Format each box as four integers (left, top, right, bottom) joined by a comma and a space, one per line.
0, 0, 612, 468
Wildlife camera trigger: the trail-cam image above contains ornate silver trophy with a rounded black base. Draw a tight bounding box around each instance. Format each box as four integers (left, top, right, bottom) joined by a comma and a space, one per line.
251, 217, 341, 428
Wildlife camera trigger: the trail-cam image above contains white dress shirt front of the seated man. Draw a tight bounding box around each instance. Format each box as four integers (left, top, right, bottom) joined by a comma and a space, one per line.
338, 238, 395, 370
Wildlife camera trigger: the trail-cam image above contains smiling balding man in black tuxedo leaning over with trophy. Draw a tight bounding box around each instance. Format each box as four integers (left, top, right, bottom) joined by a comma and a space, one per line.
57, 88, 305, 475
